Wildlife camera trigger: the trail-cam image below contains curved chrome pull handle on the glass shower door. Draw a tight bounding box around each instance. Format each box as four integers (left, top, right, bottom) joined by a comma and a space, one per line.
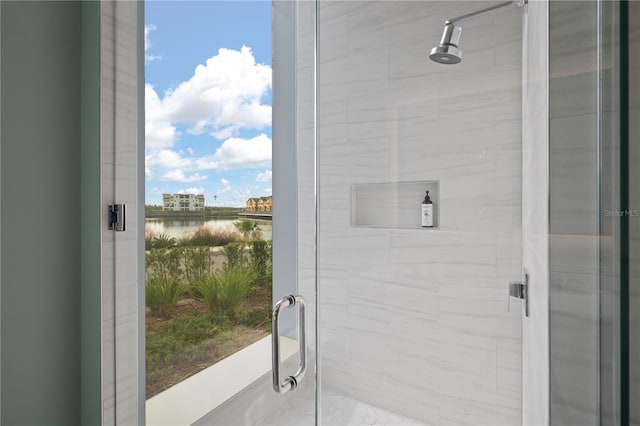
271, 295, 307, 393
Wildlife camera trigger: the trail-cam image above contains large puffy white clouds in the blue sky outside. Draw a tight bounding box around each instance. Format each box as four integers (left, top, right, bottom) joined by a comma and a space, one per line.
145, 45, 271, 182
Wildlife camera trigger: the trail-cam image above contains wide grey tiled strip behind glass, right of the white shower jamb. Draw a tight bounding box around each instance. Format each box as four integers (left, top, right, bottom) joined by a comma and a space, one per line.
549, 1, 600, 425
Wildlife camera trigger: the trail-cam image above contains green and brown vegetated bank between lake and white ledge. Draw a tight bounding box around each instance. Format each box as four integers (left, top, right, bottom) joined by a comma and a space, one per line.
145, 233, 272, 398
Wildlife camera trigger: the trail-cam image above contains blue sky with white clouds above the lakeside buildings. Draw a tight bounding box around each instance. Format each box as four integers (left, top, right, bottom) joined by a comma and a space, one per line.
145, 0, 271, 207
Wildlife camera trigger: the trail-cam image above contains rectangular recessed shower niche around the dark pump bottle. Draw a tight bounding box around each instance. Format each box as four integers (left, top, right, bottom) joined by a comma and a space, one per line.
351, 180, 440, 230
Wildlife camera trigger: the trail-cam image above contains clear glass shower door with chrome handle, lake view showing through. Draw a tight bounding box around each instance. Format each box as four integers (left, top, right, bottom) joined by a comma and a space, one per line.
145, 1, 315, 425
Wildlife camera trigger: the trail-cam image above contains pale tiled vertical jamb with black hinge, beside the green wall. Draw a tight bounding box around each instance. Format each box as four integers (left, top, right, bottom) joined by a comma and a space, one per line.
100, 1, 145, 425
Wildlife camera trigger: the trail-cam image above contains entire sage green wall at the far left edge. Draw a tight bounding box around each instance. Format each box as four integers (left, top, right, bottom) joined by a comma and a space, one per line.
0, 1, 100, 425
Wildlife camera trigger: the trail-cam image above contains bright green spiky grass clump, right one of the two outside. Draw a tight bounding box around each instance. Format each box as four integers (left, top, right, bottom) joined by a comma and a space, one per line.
197, 267, 256, 312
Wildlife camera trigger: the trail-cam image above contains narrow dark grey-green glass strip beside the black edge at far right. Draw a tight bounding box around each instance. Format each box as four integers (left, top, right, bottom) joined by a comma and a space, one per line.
599, 2, 621, 426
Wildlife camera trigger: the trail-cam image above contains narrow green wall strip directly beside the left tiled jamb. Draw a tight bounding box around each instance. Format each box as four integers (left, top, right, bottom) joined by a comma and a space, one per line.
80, 1, 102, 425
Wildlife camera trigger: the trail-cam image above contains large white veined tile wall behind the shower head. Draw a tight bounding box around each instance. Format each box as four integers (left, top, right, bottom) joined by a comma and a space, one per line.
318, 1, 522, 425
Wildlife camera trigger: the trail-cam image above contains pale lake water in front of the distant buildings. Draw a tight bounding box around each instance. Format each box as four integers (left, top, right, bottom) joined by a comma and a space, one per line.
145, 217, 273, 240
